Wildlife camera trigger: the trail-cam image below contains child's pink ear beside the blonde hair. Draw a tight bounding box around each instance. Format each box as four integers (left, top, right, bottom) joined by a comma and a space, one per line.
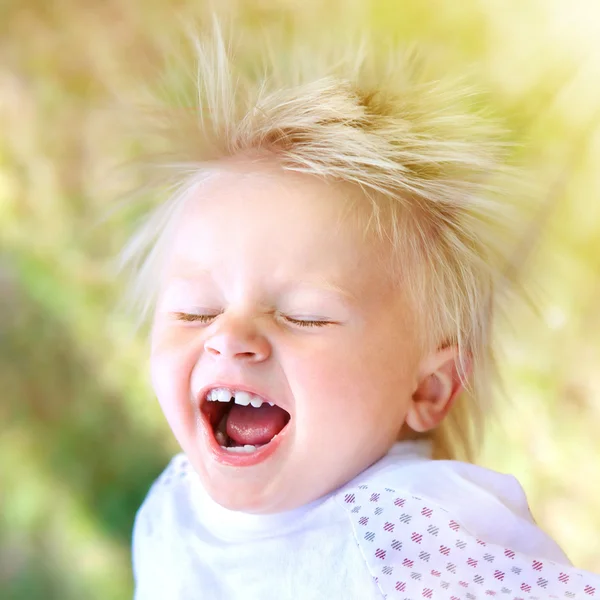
406, 346, 471, 433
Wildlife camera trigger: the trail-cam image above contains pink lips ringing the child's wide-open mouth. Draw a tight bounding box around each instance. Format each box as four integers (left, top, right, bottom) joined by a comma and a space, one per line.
198, 382, 292, 467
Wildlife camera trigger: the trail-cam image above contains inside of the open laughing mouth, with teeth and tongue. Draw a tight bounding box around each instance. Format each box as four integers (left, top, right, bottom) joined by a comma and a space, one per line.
202, 387, 290, 453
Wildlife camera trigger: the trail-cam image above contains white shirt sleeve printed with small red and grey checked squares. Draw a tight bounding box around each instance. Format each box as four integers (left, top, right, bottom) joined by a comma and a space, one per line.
339, 484, 600, 600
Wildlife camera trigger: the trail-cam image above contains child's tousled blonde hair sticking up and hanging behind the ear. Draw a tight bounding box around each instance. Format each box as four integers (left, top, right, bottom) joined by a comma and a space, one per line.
123, 23, 511, 460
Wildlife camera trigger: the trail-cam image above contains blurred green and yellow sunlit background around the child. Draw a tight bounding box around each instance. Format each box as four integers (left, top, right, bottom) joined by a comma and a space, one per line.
0, 0, 600, 600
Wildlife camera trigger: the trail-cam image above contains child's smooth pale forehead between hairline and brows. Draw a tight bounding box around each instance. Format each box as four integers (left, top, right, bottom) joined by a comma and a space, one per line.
163, 167, 394, 285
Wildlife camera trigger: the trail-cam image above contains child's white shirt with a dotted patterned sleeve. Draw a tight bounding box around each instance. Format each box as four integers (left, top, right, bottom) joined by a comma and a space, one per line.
133, 442, 600, 600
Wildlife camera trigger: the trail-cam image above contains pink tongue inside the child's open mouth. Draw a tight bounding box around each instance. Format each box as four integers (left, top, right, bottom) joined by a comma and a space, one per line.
227, 404, 289, 446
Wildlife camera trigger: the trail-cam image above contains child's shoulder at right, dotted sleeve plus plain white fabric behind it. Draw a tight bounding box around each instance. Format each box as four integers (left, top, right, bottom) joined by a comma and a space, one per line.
337, 461, 600, 600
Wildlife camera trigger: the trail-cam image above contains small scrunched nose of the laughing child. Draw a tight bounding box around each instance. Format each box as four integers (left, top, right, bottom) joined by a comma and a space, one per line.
204, 316, 271, 362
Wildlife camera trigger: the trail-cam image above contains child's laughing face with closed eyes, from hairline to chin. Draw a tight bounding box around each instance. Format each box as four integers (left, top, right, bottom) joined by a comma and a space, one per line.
151, 166, 419, 512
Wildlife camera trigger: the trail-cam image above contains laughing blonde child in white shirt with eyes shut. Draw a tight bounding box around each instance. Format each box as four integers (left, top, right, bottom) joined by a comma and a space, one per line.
123, 25, 600, 600
